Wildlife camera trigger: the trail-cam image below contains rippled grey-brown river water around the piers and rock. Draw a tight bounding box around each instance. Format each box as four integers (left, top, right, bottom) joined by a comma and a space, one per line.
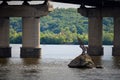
0, 45, 120, 80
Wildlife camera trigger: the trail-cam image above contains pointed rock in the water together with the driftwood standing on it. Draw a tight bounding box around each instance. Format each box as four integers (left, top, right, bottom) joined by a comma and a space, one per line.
68, 37, 94, 68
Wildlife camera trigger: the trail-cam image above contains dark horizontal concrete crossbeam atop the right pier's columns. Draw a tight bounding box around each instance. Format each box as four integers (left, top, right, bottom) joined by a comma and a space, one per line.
78, 7, 120, 17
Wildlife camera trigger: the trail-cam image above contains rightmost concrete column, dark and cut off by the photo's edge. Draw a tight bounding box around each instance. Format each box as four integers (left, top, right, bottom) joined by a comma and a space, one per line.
112, 17, 120, 56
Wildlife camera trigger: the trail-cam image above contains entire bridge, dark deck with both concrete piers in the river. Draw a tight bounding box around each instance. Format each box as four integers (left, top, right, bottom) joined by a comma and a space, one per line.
0, 0, 120, 58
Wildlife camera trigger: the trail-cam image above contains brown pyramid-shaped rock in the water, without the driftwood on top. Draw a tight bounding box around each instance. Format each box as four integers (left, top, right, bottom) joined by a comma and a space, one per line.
68, 54, 94, 68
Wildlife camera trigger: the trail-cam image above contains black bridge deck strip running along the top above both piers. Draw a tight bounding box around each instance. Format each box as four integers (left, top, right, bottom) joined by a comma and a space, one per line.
0, 0, 120, 7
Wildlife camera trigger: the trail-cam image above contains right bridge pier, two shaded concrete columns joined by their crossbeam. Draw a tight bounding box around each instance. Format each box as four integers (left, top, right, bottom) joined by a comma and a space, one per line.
78, 7, 120, 56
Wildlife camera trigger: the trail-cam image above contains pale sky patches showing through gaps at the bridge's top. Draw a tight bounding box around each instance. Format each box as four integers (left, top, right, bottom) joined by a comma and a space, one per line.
0, 1, 80, 8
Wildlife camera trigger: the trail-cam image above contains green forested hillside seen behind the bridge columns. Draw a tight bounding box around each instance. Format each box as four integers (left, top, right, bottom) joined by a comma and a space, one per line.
10, 8, 113, 44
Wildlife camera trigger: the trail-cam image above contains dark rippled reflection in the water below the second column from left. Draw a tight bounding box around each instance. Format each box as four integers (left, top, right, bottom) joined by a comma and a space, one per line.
21, 58, 40, 80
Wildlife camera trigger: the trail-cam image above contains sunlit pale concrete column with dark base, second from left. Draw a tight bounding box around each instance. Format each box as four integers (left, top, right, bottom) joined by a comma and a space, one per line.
20, 17, 41, 58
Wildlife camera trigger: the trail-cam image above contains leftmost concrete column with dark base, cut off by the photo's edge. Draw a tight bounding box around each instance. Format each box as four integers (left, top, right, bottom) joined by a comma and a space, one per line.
0, 17, 11, 57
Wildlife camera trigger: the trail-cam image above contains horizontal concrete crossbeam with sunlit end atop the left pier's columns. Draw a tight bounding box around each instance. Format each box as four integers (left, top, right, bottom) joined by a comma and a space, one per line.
0, 5, 52, 17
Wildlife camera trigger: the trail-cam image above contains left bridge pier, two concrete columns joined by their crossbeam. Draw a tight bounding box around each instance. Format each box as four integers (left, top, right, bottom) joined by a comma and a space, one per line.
0, 1, 52, 58
